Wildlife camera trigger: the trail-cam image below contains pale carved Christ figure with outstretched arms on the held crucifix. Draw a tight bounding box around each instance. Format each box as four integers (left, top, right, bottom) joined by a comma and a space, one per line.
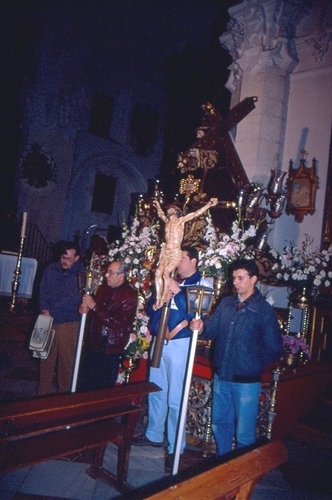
154, 198, 218, 309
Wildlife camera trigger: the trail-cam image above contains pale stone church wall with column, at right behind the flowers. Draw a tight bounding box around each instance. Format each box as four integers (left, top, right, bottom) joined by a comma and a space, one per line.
220, 0, 332, 307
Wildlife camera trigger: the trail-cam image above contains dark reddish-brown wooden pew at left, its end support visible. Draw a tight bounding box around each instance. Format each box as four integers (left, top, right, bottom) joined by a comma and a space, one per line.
0, 382, 160, 492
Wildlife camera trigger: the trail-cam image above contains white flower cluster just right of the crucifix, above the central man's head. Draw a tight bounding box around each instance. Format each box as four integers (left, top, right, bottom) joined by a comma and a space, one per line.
199, 214, 256, 277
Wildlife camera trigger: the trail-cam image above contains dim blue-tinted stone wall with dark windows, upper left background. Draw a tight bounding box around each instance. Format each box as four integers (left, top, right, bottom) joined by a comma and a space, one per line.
15, 3, 165, 248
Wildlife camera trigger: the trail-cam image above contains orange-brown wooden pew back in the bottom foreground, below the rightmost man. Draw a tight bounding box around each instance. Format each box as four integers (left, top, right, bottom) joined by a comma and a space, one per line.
121, 441, 287, 500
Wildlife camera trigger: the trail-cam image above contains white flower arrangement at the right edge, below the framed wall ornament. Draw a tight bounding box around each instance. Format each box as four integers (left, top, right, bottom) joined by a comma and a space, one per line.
270, 234, 332, 288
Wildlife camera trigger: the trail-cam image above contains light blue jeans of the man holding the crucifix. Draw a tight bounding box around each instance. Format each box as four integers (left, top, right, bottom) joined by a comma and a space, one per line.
145, 338, 190, 453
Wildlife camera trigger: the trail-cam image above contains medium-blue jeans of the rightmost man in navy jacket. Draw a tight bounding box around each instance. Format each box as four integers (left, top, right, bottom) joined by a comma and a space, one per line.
212, 375, 261, 456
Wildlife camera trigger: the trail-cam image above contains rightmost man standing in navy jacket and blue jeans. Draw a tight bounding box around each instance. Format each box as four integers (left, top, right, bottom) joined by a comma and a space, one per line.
190, 259, 283, 456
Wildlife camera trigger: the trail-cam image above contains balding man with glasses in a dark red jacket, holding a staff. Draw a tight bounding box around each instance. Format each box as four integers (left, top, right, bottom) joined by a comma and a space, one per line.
78, 261, 137, 391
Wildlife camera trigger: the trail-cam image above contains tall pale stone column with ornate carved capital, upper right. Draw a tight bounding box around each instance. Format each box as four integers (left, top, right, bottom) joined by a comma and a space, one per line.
220, 0, 307, 185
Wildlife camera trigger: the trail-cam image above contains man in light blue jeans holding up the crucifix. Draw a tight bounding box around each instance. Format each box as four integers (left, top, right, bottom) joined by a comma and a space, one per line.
132, 247, 211, 470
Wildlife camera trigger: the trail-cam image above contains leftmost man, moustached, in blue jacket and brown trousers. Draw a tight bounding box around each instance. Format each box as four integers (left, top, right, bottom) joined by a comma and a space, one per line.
37, 242, 84, 396
